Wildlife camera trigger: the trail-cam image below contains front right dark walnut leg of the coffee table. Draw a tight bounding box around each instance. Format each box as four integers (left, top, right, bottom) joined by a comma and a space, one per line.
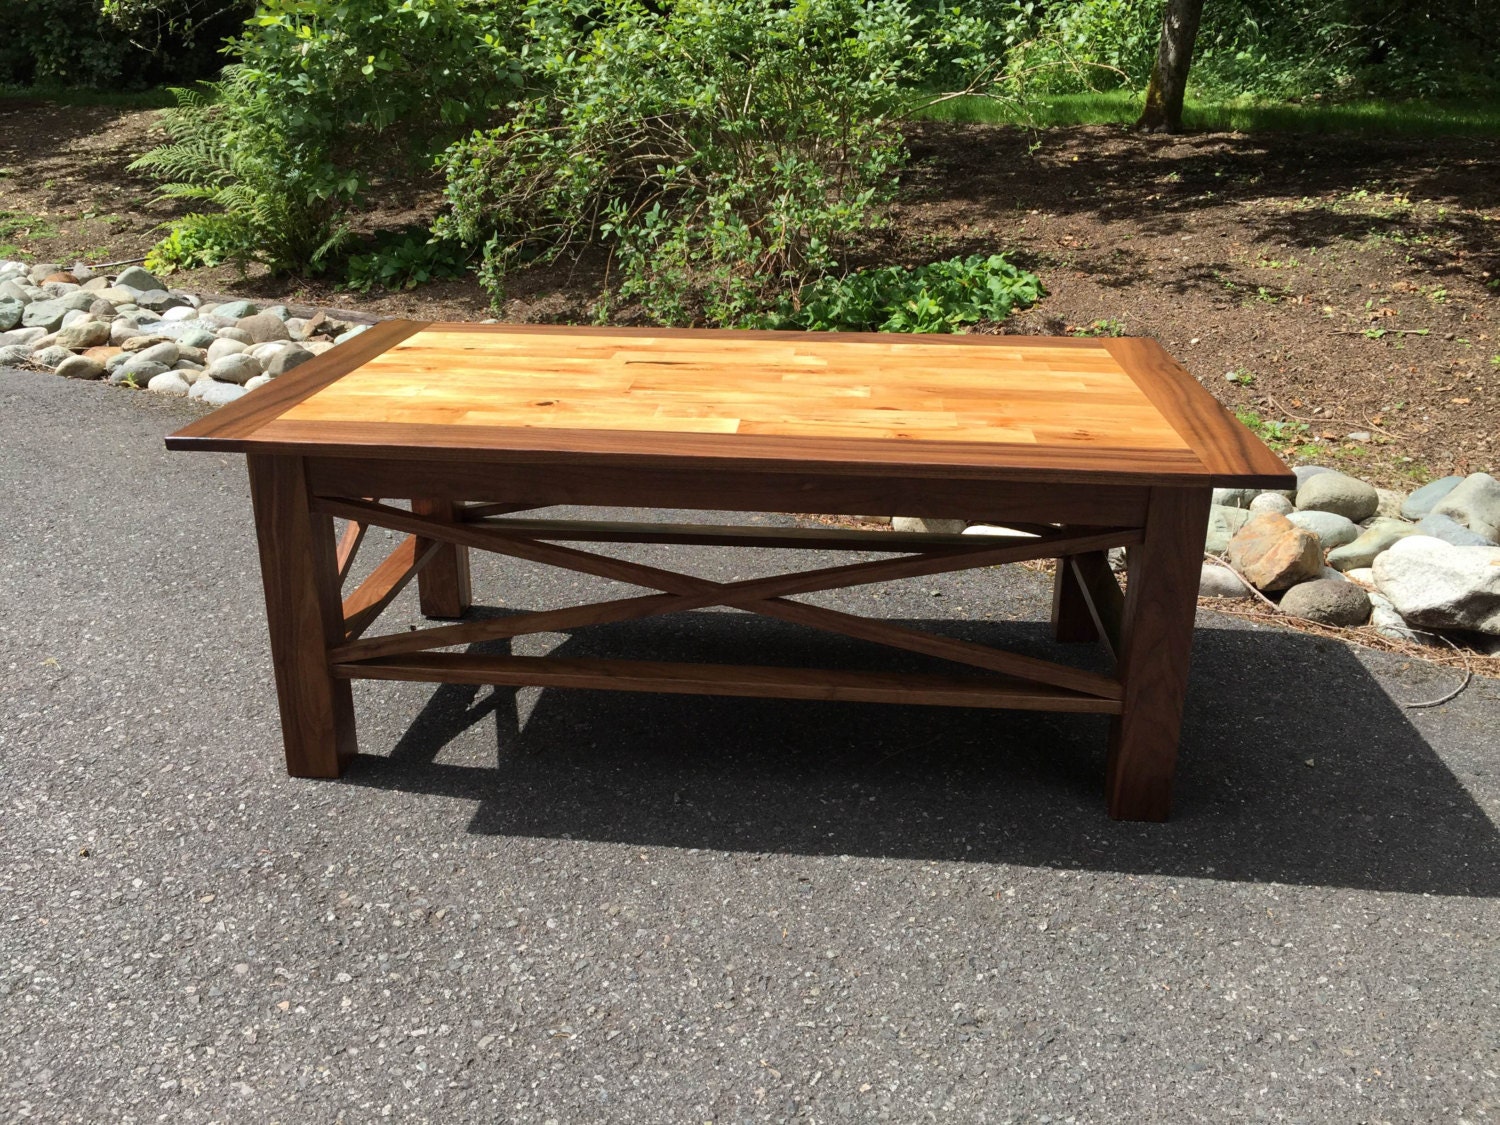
1104, 488, 1212, 821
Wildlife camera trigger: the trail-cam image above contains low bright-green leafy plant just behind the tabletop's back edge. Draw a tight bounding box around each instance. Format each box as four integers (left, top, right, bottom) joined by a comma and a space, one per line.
764, 254, 1046, 333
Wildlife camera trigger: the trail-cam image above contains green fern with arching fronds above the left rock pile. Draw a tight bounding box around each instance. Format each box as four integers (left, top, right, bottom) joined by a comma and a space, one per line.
131, 68, 359, 270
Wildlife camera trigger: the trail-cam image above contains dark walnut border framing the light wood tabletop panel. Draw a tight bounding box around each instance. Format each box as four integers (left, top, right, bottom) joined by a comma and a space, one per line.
167, 321, 1295, 489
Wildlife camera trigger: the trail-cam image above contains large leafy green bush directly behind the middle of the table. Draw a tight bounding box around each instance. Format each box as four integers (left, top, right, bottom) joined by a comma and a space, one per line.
438, 0, 929, 324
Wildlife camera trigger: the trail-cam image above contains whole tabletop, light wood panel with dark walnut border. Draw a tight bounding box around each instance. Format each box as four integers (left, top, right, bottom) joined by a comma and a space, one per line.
168, 323, 1290, 486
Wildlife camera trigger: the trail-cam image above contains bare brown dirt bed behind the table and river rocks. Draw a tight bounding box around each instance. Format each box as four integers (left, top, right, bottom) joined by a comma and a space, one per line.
0, 101, 1500, 486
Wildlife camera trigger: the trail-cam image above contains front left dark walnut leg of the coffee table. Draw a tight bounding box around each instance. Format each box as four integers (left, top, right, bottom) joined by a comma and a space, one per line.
248, 455, 357, 777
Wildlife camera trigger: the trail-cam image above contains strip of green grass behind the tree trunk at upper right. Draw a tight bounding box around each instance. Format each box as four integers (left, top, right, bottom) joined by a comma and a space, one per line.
920, 90, 1500, 137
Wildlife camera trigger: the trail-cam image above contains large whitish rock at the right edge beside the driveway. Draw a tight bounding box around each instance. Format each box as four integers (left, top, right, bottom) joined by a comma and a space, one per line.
1376, 536, 1500, 636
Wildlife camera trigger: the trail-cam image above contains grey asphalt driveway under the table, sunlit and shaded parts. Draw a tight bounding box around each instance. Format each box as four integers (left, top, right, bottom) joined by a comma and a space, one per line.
0, 372, 1500, 1125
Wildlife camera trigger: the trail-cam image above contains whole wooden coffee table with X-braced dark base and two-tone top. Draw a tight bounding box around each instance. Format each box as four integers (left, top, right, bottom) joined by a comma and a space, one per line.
167, 321, 1295, 821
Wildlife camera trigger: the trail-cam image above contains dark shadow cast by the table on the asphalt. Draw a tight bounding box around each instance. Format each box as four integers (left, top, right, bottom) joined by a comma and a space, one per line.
345, 611, 1500, 897
